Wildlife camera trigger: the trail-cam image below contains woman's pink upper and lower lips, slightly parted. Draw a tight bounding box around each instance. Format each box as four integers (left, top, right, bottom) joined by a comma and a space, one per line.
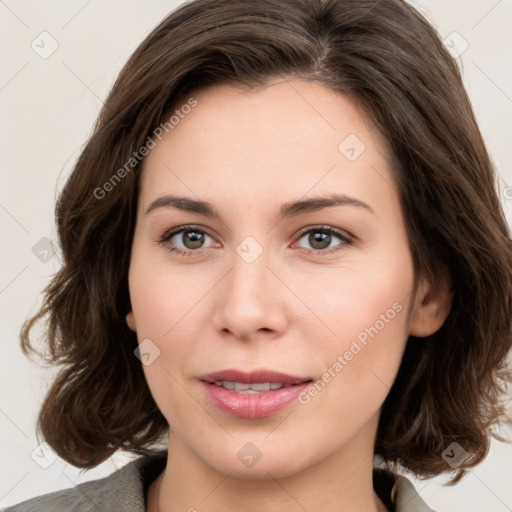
201, 370, 312, 419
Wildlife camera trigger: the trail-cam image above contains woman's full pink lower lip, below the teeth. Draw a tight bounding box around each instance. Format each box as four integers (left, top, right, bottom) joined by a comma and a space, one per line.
201, 381, 311, 419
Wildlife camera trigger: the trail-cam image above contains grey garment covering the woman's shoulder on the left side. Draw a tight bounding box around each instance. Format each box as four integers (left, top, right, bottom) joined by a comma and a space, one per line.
2, 452, 166, 512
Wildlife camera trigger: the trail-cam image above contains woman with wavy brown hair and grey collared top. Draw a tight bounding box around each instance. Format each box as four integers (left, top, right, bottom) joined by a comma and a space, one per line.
8, 0, 512, 512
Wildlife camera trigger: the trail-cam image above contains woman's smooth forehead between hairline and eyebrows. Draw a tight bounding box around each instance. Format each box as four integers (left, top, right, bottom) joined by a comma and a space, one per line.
141, 80, 397, 216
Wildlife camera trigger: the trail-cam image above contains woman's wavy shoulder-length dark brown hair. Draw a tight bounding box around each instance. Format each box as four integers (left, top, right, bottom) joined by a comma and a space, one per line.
21, 0, 512, 482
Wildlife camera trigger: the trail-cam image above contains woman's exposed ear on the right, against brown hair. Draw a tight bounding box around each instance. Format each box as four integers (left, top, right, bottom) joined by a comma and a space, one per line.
409, 273, 453, 337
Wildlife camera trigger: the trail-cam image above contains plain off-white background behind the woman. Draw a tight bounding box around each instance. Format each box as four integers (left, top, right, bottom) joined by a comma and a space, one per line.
0, 0, 512, 512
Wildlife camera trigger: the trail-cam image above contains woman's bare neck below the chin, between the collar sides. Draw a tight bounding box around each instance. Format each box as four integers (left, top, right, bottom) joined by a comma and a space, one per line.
147, 426, 387, 512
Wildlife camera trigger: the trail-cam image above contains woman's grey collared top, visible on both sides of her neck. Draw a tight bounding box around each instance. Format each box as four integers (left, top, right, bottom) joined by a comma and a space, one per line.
2, 451, 434, 512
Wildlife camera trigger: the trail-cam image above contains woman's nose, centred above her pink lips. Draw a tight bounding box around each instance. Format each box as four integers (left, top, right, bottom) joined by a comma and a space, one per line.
213, 242, 288, 341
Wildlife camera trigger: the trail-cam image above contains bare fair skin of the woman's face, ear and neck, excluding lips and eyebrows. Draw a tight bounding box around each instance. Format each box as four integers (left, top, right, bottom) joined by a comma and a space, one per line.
127, 79, 449, 512
